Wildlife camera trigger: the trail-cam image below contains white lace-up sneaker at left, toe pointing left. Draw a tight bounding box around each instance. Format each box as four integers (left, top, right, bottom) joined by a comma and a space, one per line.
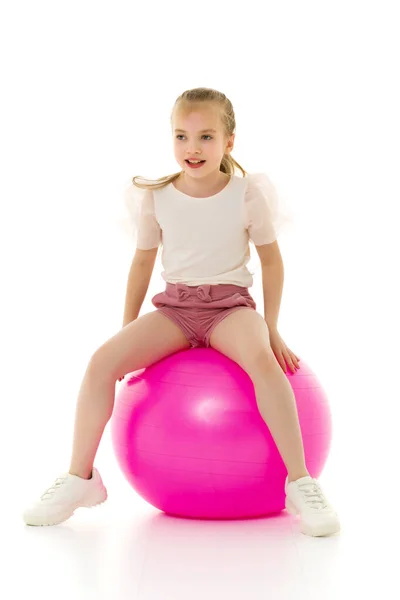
22, 468, 107, 525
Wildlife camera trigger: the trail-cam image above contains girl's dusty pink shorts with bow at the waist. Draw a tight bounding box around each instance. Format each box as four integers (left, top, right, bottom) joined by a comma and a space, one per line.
151, 282, 256, 348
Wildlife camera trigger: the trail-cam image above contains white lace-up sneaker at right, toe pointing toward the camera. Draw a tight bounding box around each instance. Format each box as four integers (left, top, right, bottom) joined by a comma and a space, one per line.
285, 475, 340, 536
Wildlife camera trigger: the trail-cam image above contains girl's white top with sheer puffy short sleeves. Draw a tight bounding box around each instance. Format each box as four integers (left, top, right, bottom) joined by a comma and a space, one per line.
123, 173, 291, 287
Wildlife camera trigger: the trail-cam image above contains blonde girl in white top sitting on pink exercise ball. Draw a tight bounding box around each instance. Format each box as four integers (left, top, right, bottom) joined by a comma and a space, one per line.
23, 88, 340, 536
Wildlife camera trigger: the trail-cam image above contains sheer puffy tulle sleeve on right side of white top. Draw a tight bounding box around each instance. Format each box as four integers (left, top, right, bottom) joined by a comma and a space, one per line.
245, 173, 293, 246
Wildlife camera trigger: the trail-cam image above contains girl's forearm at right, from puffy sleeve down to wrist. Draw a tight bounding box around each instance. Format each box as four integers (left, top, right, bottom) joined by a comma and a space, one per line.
256, 240, 284, 331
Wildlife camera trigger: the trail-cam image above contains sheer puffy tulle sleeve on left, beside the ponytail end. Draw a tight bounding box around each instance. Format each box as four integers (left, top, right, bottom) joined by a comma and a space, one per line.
119, 181, 162, 250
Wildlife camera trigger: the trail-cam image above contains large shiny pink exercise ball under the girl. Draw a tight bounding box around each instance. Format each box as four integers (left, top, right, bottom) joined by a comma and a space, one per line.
111, 347, 332, 519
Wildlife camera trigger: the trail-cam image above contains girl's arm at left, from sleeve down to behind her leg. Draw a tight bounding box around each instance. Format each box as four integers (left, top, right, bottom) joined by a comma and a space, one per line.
122, 248, 158, 327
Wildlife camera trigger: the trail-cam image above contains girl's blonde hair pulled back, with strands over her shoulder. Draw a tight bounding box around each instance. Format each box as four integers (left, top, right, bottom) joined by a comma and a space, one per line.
132, 87, 247, 190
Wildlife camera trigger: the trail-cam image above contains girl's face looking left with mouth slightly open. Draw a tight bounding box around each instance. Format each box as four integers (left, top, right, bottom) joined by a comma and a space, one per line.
172, 106, 235, 178
